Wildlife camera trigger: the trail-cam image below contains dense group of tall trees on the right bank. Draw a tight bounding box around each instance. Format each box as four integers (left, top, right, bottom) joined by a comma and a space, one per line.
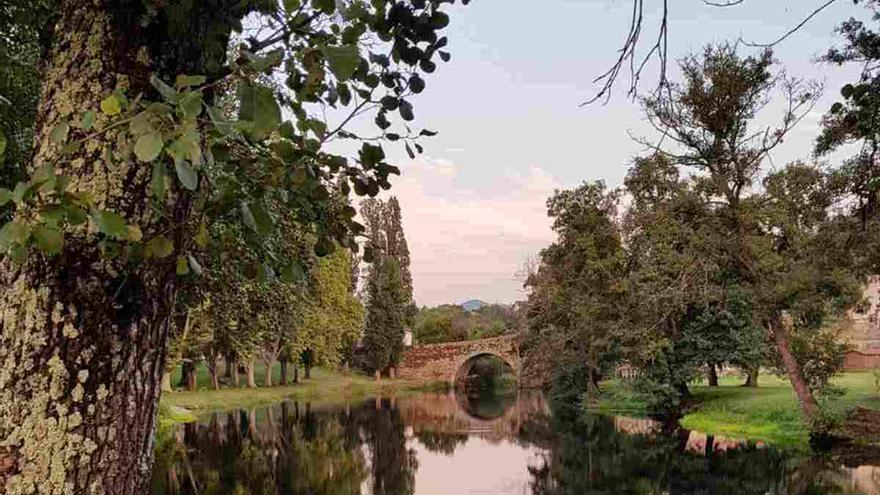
526, 39, 880, 430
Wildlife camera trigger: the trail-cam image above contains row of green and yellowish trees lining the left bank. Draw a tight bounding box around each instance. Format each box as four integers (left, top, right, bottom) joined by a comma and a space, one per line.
163, 197, 414, 390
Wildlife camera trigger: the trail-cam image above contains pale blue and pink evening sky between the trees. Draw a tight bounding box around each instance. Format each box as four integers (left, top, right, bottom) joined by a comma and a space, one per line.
348, 0, 865, 306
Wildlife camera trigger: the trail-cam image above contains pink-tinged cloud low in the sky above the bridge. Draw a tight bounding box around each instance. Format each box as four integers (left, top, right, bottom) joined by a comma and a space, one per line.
380, 158, 562, 305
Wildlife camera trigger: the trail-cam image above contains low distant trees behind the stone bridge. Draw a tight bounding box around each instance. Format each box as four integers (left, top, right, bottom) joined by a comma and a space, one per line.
413, 304, 522, 344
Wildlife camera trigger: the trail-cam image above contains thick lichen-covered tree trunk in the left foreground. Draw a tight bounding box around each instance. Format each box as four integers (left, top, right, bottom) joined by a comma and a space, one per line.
0, 0, 244, 495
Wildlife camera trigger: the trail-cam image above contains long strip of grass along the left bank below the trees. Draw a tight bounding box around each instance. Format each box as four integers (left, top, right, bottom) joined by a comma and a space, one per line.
162, 366, 440, 420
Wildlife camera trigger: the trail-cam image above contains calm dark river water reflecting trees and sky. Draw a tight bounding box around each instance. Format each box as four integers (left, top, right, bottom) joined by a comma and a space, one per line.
153, 392, 880, 495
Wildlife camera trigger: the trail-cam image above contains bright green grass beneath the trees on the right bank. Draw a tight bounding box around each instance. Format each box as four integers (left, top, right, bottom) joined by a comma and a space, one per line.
590, 372, 880, 447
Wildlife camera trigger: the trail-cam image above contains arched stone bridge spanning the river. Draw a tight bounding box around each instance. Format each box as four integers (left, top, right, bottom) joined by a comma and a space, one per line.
397, 334, 520, 384
